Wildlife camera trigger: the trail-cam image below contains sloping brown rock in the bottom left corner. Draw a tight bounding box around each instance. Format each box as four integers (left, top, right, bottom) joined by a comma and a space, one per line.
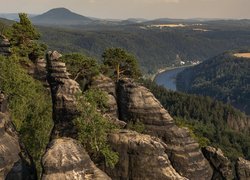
0, 92, 35, 180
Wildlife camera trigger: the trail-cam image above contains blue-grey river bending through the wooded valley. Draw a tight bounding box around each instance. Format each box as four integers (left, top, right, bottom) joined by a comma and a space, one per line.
154, 67, 187, 91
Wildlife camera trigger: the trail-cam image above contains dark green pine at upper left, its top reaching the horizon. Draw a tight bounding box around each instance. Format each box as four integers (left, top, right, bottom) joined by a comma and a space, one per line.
7, 13, 47, 60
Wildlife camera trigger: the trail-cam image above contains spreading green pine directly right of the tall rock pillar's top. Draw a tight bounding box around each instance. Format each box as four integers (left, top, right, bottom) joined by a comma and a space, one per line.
61, 53, 99, 89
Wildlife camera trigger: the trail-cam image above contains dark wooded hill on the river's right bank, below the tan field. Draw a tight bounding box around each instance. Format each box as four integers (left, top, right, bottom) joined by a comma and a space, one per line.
177, 51, 250, 114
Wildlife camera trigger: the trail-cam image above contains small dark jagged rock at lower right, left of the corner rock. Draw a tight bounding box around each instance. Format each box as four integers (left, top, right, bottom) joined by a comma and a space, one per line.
202, 146, 234, 180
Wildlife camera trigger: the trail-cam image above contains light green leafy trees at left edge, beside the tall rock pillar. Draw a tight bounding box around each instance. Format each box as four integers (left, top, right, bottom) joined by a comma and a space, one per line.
0, 57, 52, 176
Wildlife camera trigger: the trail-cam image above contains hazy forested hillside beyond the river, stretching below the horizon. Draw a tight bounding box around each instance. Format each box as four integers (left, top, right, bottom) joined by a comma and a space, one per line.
39, 22, 250, 73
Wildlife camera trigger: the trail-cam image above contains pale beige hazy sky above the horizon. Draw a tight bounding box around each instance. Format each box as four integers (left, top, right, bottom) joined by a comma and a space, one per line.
0, 0, 250, 19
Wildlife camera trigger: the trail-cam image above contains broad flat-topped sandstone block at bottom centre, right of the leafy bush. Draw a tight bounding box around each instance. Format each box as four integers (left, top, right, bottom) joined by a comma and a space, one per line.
106, 130, 186, 180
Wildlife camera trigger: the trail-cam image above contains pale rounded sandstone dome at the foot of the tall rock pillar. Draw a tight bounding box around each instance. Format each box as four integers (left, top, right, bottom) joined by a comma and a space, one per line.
42, 138, 110, 180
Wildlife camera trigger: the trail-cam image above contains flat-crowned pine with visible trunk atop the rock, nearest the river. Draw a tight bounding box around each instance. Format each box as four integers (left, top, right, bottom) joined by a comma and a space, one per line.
102, 48, 141, 80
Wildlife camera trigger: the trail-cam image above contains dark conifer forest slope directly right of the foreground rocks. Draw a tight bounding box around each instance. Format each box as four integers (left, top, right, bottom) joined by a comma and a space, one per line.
143, 80, 250, 160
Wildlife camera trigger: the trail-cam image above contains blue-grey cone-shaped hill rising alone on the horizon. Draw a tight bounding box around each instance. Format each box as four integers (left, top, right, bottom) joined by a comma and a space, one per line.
31, 8, 95, 26
